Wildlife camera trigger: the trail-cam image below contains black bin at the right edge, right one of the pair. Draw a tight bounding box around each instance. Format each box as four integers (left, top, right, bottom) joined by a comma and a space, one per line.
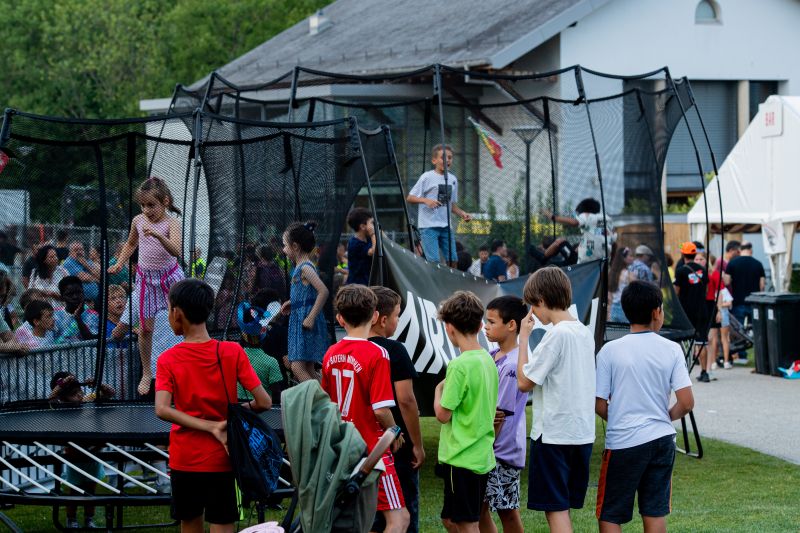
764, 292, 800, 376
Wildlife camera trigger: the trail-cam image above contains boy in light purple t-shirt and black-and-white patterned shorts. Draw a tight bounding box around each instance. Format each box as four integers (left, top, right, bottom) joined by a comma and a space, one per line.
480, 296, 528, 533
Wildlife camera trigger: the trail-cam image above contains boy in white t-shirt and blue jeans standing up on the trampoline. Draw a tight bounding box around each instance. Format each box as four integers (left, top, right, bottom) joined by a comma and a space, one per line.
406, 144, 472, 268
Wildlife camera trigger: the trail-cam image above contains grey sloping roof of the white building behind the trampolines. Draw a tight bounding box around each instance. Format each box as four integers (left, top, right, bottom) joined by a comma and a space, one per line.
191, 0, 610, 89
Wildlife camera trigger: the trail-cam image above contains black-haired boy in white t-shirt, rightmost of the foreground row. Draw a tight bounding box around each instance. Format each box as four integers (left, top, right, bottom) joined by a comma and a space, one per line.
595, 280, 694, 533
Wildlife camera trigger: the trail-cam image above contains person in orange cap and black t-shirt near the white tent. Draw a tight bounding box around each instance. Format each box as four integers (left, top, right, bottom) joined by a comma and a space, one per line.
674, 242, 713, 383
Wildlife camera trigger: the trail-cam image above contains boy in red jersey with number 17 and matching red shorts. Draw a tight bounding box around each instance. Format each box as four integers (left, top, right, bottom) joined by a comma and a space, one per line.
322, 285, 409, 533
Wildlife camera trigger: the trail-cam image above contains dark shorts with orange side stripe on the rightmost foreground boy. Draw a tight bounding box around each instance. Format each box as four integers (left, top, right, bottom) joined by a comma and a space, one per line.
597, 435, 675, 524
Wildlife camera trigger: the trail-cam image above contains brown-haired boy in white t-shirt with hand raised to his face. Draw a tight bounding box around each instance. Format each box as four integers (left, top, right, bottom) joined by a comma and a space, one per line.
517, 267, 595, 531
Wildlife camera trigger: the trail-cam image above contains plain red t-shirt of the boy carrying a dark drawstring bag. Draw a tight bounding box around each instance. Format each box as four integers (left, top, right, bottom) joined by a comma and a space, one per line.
156, 339, 261, 472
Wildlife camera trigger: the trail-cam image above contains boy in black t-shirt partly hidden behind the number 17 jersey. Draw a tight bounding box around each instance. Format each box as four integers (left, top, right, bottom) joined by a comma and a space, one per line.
369, 287, 425, 532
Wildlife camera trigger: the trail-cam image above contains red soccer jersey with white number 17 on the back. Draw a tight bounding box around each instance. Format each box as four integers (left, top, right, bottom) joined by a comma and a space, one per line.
322, 337, 394, 451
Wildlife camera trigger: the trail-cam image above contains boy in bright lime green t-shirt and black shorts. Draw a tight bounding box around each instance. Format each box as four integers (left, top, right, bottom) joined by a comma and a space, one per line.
433, 291, 498, 533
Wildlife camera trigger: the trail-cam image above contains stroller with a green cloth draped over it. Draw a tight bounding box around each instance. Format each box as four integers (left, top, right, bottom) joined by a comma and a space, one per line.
281, 380, 399, 533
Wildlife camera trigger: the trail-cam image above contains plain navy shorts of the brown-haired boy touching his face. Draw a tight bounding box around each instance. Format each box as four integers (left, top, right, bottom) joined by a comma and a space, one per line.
528, 437, 592, 511
